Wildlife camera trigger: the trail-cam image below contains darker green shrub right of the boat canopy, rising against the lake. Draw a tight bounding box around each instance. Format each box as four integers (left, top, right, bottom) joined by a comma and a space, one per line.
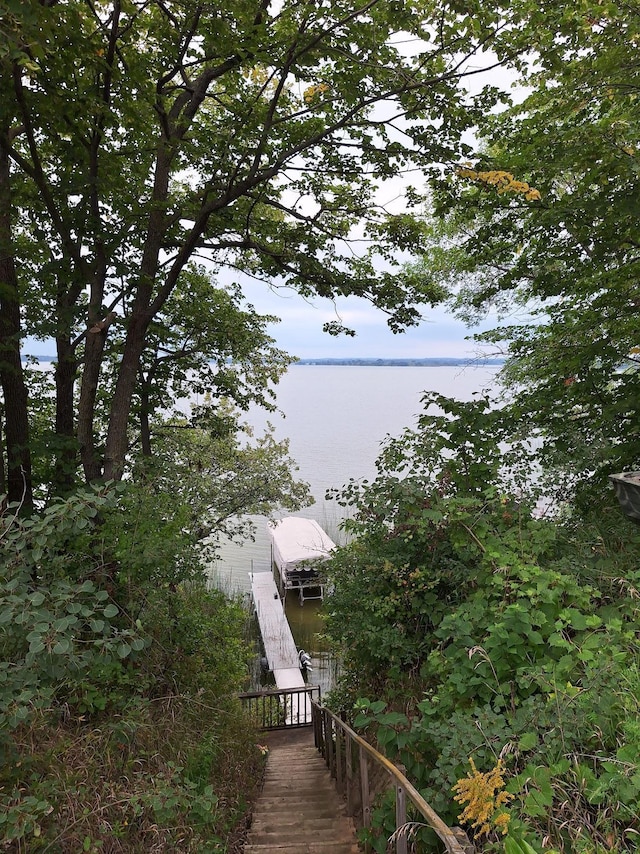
327, 395, 540, 688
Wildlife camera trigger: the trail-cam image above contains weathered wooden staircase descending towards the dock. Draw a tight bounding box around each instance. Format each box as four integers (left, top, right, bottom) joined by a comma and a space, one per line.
244, 728, 360, 854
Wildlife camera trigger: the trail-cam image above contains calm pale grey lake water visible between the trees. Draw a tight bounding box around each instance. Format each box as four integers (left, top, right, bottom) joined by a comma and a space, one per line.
212, 365, 498, 592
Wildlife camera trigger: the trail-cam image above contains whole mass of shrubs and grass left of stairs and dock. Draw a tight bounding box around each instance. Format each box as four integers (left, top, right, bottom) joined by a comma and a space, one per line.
0, 485, 261, 852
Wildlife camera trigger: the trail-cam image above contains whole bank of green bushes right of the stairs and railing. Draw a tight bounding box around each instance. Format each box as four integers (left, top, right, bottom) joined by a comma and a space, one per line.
328, 399, 640, 854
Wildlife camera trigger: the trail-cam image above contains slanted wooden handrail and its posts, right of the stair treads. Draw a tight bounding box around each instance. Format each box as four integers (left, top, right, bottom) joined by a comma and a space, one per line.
311, 700, 468, 854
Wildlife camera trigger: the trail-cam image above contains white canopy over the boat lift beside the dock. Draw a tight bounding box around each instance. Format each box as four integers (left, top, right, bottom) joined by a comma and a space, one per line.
268, 516, 336, 578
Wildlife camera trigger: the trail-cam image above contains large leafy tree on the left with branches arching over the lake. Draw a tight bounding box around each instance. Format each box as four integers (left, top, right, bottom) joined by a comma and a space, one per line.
0, 0, 516, 498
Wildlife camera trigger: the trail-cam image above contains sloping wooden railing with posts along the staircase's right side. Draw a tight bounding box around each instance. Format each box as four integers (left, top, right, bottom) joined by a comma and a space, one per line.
311, 701, 473, 854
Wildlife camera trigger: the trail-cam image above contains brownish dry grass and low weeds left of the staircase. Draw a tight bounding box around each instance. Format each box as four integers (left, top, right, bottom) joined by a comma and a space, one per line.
0, 699, 263, 854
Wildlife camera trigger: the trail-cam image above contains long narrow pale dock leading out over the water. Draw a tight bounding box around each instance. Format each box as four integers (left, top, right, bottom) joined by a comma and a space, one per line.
249, 572, 311, 724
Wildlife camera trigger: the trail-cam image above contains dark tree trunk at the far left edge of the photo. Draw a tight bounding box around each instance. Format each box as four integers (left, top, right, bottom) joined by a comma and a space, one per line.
0, 138, 33, 513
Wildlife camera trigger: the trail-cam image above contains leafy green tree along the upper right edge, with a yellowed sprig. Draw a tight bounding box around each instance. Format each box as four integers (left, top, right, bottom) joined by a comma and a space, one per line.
410, 3, 640, 504
